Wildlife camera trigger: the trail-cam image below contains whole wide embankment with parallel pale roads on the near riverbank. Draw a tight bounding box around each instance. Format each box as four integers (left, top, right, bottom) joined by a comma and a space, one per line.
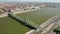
27, 15, 60, 33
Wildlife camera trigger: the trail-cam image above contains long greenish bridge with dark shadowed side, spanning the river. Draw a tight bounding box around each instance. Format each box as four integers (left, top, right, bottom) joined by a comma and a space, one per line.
8, 12, 40, 30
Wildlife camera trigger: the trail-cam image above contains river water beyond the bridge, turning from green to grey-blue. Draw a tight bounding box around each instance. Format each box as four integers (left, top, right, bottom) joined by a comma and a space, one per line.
17, 8, 60, 24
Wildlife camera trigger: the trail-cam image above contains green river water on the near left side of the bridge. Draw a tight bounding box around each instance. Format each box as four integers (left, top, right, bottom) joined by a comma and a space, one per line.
0, 17, 30, 34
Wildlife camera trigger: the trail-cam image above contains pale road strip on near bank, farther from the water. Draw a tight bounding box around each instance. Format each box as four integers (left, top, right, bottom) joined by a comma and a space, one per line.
42, 16, 60, 34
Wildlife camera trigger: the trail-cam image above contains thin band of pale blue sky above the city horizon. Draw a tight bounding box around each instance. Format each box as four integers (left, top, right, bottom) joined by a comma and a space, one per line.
0, 0, 60, 3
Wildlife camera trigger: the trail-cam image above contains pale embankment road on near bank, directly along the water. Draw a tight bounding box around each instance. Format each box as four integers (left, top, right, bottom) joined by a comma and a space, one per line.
33, 15, 59, 33
